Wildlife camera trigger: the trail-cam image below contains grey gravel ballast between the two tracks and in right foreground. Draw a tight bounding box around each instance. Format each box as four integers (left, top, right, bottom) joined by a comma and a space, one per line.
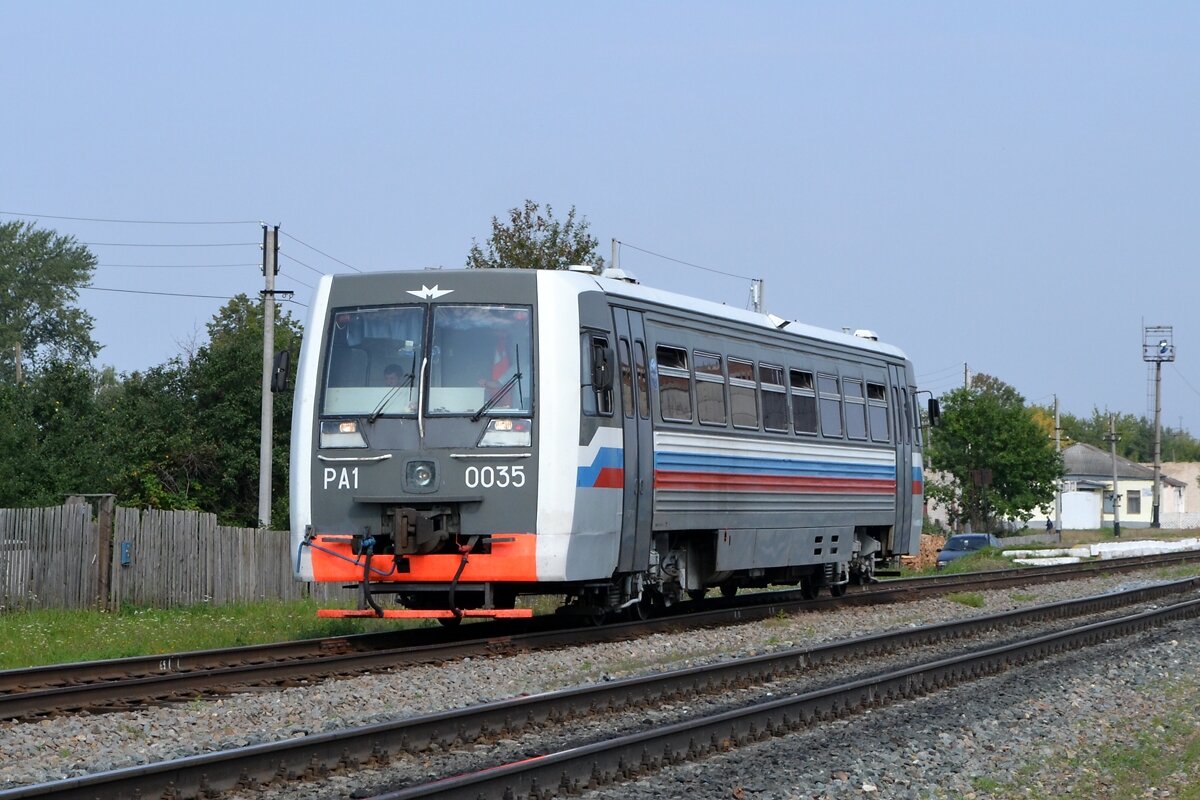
0, 568, 1200, 800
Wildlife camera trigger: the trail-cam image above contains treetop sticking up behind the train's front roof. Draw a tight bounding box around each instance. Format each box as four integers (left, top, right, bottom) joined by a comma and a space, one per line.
467, 200, 604, 270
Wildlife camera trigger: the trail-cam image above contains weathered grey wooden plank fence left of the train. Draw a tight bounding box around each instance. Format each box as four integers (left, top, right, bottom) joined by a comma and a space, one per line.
0, 497, 353, 610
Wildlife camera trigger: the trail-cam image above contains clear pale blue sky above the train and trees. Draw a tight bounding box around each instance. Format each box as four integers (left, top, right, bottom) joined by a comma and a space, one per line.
0, 0, 1200, 434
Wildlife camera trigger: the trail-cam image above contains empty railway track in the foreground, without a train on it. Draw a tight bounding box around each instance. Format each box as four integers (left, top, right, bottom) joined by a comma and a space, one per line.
0, 578, 1200, 800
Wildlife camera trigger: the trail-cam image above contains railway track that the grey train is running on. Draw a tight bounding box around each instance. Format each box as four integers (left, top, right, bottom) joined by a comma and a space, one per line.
0, 553, 1200, 720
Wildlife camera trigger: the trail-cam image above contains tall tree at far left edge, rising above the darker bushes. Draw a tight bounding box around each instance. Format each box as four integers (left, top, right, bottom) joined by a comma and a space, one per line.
0, 222, 100, 383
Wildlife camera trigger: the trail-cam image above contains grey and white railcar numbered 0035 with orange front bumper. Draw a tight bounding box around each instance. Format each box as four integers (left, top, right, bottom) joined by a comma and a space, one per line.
290, 266, 923, 624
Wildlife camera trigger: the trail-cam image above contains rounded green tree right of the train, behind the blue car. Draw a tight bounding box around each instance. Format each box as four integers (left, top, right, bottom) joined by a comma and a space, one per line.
925, 374, 1062, 530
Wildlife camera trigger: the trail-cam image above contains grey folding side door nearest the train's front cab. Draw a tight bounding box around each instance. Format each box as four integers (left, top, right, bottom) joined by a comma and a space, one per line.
612, 308, 654, 572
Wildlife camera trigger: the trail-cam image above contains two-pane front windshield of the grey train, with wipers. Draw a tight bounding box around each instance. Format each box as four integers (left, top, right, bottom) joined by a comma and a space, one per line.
322, 305, 533, 416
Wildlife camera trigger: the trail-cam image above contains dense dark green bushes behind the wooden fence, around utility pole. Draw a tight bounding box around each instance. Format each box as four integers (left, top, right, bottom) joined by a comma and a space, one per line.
0, 295, 300, 528
